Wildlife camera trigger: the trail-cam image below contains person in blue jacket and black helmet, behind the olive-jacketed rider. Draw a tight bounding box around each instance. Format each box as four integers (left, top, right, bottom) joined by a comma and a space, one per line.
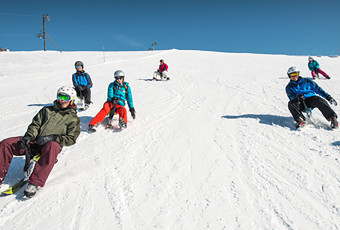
72, 61, 92, 109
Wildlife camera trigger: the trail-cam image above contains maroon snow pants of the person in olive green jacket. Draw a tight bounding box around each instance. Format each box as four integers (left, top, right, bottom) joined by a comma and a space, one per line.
0, 137, 61, 187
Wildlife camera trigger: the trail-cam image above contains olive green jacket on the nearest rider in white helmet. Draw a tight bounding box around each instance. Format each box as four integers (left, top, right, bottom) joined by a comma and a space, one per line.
25, 101, 80, 147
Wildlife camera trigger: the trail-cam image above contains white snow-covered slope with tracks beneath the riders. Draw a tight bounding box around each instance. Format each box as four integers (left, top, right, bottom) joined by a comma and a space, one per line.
0, 50, 340, 230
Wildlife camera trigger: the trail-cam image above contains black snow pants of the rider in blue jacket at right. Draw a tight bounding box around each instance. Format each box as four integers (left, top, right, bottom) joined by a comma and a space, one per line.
288, 96, 337, 121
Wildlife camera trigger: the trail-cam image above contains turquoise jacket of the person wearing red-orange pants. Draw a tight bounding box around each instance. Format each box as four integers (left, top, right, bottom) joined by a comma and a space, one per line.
107, 81, 133, 108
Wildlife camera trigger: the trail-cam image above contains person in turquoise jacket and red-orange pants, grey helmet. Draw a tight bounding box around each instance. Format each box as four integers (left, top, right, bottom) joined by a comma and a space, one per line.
89, 70, 136, 132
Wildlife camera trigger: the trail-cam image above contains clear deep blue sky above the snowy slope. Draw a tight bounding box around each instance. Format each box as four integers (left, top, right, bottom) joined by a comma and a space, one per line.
0, 0, 340, 55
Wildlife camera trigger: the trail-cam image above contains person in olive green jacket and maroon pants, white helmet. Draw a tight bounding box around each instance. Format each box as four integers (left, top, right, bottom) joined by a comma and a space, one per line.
0, 86, 80, 198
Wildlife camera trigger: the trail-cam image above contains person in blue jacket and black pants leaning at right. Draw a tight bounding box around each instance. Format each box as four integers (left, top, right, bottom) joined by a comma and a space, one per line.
286, 66, 339, 128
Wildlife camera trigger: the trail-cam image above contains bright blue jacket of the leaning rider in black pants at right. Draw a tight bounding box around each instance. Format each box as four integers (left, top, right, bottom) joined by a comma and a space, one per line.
286, 77, 329, 100
